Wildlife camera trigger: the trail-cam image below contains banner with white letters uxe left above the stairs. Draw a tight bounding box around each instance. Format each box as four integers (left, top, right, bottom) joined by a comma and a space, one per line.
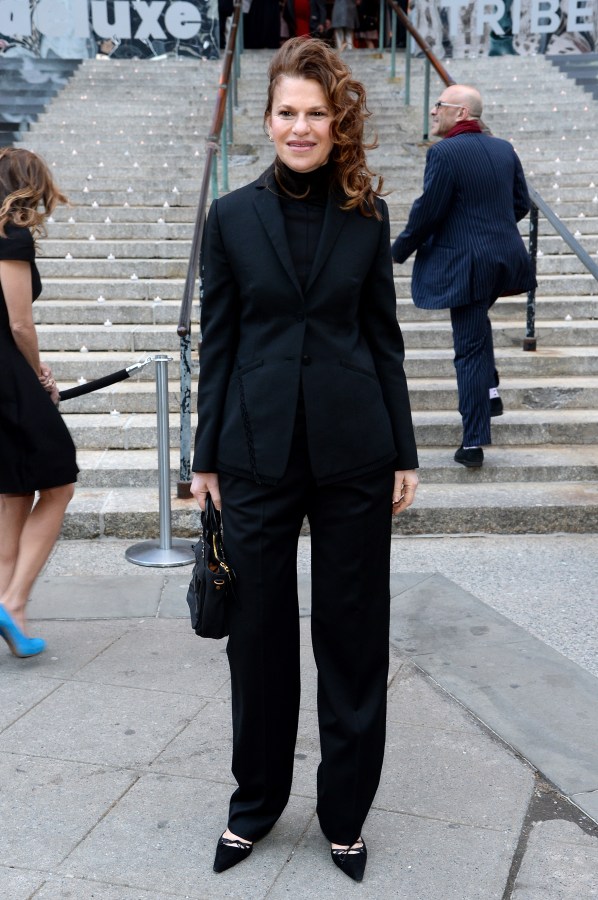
0, 0, 219, 59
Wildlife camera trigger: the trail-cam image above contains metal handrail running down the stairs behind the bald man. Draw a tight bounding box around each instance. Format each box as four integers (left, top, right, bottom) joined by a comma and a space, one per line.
380, 7, 598, 350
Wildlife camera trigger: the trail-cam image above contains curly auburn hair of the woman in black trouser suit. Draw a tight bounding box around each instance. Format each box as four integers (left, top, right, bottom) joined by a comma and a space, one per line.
264, 37, 383, 219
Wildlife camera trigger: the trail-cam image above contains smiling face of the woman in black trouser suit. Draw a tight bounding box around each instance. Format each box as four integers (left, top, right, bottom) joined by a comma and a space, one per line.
266, 75, 333, 172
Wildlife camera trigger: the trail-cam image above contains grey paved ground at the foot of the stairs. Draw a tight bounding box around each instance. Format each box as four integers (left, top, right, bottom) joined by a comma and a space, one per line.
0, 535, 598, 900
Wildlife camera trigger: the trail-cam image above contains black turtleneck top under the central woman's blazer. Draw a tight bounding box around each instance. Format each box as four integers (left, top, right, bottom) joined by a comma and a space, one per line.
277, 162, 332, 289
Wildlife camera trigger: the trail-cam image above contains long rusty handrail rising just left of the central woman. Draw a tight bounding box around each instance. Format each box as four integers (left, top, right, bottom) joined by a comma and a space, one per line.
177, 0, 242, 498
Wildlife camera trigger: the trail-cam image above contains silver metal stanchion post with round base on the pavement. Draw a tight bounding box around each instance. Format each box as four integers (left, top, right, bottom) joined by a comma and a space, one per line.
125, 355, 195, 567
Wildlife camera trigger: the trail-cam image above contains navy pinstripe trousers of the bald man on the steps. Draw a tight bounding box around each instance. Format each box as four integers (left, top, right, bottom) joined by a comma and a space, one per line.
451, 300, 498, 447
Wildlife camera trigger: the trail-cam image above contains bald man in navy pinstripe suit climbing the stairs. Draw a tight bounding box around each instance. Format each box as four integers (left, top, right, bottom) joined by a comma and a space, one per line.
392, 84, 536, 467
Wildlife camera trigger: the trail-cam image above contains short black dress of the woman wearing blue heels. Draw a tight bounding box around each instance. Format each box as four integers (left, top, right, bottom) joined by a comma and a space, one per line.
0, 225, 79, 494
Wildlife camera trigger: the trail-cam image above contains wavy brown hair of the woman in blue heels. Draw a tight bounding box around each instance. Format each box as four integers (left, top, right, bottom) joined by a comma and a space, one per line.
0, 147, 68, 237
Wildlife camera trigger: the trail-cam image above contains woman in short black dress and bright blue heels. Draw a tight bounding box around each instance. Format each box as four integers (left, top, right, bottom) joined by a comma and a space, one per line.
0, 147, 78, 657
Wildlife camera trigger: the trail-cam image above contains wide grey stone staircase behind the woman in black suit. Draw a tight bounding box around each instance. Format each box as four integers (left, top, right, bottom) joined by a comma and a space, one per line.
16, 51, 598, 539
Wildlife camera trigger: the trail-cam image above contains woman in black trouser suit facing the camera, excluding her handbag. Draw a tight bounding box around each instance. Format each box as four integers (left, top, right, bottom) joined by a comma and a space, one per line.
191, 38, 417, 880
